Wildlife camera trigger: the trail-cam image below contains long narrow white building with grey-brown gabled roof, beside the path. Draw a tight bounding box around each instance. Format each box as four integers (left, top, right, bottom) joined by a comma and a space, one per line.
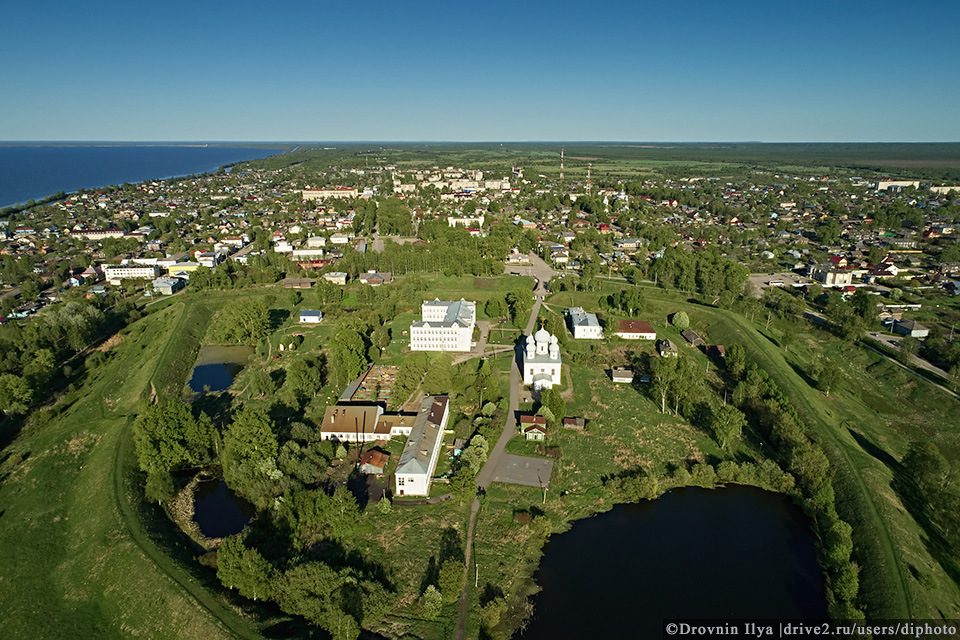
393, 396, 450, 496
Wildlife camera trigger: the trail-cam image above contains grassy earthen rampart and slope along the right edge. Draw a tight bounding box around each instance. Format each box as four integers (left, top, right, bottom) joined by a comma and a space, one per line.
650, 292, 960, 618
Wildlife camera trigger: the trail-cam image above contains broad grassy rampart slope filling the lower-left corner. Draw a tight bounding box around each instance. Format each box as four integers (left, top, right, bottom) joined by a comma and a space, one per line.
0, 304, 278, 638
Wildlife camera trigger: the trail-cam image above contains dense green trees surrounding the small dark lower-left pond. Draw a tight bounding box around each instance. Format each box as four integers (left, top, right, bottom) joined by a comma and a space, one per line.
133, 384, 395, 640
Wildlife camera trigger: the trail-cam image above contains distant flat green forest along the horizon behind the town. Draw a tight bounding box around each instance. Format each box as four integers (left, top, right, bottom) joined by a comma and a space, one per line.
238, 142, 960, 182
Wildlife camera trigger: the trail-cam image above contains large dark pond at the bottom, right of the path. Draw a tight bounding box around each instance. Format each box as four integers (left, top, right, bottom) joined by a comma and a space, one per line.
519, 486, 827, 640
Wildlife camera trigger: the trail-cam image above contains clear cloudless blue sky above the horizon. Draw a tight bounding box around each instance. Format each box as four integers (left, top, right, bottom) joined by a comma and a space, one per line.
0, 0, 960, 142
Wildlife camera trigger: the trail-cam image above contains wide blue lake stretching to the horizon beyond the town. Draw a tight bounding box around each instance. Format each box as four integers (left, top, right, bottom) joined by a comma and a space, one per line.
0, 144, 283, 207
